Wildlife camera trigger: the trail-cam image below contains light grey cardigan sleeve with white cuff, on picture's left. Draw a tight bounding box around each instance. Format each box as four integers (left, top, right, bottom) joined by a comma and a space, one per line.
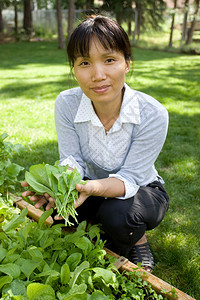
55, 94, 85, 178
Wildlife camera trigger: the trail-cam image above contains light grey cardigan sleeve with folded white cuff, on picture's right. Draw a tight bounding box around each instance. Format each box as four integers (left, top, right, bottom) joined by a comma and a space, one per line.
109, 100, 168, 199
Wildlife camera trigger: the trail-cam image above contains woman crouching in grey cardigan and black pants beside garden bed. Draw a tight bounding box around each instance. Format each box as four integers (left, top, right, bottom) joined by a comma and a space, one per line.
23, 16, 169, 271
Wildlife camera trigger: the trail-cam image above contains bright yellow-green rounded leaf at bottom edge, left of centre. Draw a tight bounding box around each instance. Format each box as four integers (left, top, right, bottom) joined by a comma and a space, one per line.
27, 283, 56, 300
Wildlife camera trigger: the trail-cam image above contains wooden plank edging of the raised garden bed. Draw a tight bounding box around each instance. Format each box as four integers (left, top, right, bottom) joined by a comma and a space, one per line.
12, 197, 195, 300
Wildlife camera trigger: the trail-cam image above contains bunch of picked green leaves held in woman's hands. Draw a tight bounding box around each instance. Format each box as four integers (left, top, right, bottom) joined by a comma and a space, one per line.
25, 163, 86, 225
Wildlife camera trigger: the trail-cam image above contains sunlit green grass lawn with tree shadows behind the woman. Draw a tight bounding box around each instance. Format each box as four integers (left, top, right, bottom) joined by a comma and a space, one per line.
0, 42, 200, 299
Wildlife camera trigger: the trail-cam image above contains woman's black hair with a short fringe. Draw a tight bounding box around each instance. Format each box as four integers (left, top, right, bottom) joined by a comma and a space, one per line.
67, 15, 131, 67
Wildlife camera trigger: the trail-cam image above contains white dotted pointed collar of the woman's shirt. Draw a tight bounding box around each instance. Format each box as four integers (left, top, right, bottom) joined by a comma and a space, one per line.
74, 83, 140, 126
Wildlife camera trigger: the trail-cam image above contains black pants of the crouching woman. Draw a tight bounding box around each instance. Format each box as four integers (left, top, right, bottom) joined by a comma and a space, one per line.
73, 181, 169, 256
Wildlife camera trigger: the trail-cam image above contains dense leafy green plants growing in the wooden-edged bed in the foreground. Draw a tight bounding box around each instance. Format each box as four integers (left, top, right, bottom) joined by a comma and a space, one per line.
0, 209, 170, 300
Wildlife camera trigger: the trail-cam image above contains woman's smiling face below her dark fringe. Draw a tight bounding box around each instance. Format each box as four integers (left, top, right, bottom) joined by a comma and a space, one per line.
74, 38, 130, 106
